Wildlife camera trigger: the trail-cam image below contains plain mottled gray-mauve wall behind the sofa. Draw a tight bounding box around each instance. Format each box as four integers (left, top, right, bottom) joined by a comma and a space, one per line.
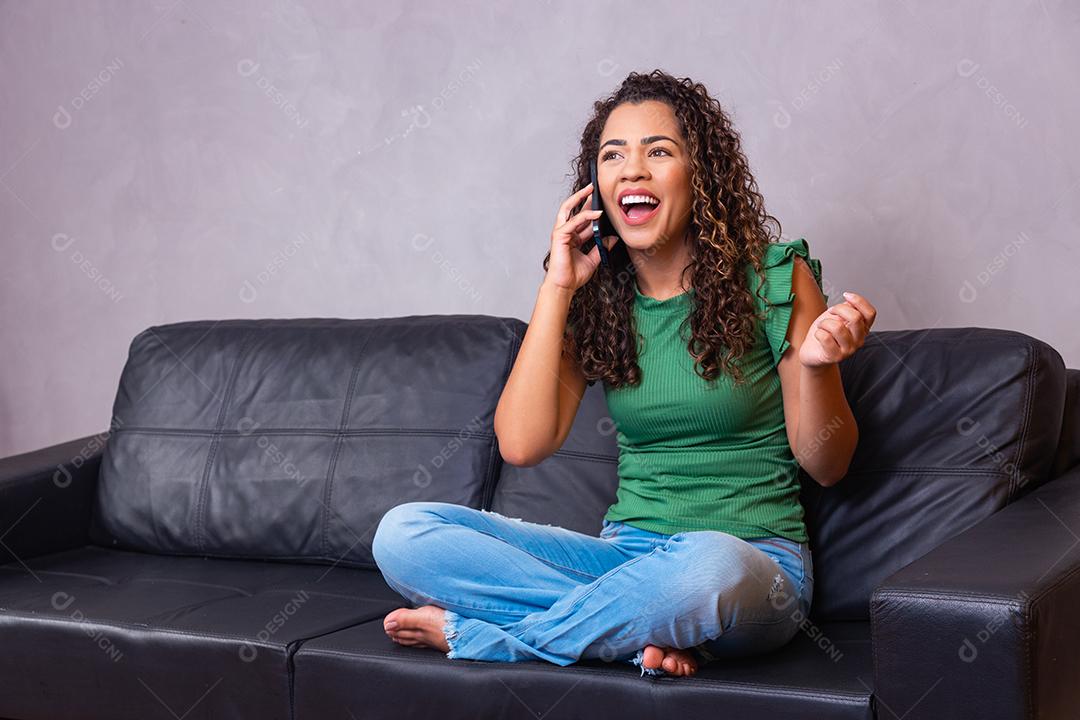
0, 0, 1080, 456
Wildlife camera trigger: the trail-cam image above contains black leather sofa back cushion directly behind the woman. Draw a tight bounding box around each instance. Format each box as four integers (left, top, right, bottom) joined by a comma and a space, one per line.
492, 327, 1066, 620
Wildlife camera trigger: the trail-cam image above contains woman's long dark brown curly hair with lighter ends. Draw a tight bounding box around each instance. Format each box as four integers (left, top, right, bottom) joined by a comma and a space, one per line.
543, 69, 781, 388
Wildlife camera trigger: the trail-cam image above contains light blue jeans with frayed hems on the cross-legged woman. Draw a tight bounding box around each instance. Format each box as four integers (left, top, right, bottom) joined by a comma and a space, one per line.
372, 502, 813, 675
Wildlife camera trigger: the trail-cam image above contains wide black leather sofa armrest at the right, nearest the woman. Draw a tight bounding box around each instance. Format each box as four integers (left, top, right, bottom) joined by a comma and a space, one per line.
870, 467, 1080, 720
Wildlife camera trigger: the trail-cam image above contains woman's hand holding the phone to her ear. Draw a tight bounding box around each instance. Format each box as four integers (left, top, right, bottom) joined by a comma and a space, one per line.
544, 182, 619, 291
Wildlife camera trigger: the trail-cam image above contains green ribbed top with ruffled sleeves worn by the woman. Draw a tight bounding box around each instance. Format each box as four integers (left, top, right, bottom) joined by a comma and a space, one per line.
604, 237, 828, 542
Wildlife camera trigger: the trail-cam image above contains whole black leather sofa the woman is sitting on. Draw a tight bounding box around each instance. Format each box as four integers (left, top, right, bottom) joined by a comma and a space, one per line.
0, 315, 1080, 720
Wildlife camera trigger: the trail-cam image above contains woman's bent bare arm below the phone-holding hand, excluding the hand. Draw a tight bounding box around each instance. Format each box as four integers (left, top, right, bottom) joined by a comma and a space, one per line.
495, 282, 585, 466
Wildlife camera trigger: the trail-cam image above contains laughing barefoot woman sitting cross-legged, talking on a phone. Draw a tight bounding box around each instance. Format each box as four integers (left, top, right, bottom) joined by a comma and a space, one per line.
374, 70, 876, 675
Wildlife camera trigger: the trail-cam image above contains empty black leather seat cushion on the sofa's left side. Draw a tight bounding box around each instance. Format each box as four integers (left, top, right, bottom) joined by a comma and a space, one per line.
0, 546, 402, 720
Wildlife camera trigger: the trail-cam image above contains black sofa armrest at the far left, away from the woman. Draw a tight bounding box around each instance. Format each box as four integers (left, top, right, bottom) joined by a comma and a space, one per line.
0, 433, 108, 567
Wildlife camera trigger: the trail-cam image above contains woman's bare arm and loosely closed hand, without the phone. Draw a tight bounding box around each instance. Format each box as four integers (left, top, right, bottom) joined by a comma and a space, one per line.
777, 258, 875, 487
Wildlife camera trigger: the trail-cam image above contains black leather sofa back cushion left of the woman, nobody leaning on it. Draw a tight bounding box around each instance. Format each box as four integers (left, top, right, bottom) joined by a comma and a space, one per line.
91, 315, 523, 569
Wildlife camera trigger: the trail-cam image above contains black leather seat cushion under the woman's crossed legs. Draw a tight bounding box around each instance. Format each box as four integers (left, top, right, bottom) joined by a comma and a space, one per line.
294, 620, 874, 720
